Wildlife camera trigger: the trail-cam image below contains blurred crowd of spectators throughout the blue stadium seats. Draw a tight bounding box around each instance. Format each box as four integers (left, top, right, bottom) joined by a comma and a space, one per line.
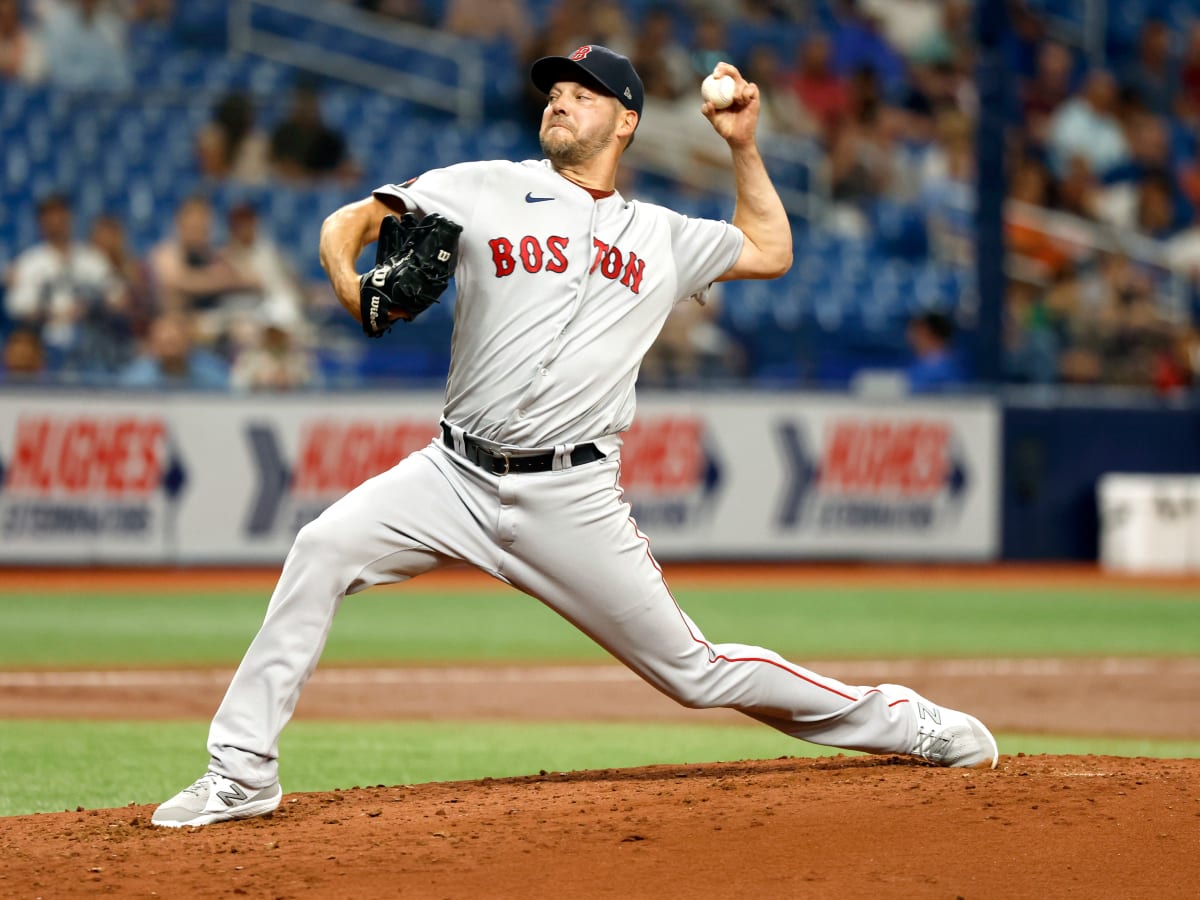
0, 0, 1200, 391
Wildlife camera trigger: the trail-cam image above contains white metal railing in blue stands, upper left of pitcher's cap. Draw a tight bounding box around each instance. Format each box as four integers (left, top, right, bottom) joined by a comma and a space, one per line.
229, 0, 484, 124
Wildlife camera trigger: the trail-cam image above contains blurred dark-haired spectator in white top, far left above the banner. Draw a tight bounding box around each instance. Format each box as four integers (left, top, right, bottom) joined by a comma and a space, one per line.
5, 194, 126, 370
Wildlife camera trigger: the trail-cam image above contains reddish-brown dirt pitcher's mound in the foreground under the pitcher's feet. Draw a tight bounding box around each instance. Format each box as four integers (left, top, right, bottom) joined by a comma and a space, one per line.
0, 756, 1200, 900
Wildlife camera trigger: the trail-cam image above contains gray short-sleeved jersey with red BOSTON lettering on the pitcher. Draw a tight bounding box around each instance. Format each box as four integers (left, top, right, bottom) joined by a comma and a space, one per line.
374, 161, 743, 448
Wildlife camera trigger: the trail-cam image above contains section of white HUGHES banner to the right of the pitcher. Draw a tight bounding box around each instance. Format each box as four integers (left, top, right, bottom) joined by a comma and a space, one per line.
622, 395, 1000, 559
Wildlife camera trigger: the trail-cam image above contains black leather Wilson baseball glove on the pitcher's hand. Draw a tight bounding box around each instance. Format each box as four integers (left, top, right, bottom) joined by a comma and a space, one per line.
359, 212, 462, 337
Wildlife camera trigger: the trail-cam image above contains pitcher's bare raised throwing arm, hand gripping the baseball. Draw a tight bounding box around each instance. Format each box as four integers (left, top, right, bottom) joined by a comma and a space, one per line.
701, 62, 792, 281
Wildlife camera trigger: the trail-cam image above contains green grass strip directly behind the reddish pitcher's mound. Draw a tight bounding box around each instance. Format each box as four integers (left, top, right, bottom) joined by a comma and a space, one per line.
0, 720, 1200, 816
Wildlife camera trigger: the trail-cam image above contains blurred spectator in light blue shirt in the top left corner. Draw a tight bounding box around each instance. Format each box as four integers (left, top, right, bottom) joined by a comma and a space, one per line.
42, 0, 133, 90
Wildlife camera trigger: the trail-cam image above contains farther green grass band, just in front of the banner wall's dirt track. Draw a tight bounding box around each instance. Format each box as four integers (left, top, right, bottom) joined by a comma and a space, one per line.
0, 586, 1200, 668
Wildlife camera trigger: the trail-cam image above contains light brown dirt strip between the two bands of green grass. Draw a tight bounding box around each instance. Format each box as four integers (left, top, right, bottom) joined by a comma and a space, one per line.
0, 659, 1200, 739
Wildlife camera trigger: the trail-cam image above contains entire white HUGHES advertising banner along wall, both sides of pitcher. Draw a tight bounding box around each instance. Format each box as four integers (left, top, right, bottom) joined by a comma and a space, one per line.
0, 394, 1000, 565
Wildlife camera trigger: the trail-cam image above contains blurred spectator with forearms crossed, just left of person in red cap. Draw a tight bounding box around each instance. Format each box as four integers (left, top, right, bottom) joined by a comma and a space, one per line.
150, 196, 262, 350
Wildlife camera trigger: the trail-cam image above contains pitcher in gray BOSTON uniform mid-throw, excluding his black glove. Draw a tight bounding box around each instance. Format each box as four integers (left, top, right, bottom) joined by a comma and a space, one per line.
154, 46, 998, 827
